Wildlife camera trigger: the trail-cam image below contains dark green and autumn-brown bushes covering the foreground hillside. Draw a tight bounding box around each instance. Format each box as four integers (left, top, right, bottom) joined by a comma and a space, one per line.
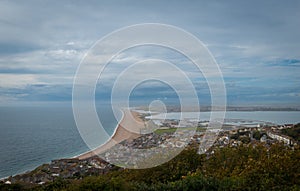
0, 143, 300, 191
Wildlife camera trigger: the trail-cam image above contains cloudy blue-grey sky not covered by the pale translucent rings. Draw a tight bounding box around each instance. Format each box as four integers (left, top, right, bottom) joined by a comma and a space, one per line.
0, 0, 300, 107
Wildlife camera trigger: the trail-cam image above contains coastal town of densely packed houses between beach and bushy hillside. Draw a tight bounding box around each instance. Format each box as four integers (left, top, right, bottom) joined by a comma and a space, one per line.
2, 111, 299, 184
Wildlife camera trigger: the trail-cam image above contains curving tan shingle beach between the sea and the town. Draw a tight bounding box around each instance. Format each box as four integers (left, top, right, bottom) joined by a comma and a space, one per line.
73, 109, 145, 160
